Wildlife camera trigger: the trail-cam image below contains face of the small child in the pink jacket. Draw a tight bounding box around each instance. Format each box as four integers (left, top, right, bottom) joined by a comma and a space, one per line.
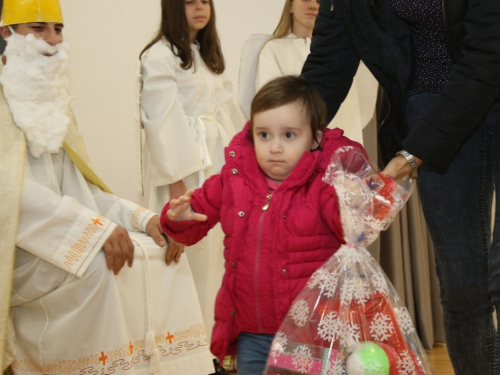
253, 103, 321, 182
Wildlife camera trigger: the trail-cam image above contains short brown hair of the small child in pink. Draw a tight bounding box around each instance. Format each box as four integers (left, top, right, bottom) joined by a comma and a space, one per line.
248, 76, 328, 144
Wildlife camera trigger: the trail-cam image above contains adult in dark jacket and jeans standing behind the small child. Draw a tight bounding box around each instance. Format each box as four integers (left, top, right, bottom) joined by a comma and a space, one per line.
302, 0, 500, 375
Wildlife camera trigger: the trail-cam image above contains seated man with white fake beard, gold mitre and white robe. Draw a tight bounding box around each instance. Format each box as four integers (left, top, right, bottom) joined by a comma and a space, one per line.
0, 0, 213, 375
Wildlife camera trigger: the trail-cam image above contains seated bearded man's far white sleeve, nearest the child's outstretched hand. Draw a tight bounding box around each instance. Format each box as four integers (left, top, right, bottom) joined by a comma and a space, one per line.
88, 183, 156, 232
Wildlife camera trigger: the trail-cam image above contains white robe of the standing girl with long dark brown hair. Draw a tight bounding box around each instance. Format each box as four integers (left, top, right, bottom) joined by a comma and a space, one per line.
141, 40, 245, 346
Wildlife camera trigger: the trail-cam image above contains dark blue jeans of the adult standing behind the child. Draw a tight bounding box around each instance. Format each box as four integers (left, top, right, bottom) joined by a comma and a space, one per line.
407, 93, 500, 375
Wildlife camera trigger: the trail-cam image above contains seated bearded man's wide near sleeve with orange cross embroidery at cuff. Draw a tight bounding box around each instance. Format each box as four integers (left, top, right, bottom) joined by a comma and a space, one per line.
16, 178, 116, 277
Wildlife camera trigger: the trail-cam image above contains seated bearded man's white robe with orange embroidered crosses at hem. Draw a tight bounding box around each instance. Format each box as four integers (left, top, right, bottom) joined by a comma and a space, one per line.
11, 149, 213, 375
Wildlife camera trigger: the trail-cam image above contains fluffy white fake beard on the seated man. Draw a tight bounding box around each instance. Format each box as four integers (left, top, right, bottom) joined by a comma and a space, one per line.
0, 33, 71, 158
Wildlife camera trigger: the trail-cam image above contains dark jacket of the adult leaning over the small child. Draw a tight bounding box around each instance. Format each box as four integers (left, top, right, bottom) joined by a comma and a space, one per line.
302, 0, 500, 173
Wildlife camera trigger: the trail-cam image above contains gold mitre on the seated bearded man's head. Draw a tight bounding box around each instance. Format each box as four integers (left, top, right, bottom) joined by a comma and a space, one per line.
2, 0, 63, 26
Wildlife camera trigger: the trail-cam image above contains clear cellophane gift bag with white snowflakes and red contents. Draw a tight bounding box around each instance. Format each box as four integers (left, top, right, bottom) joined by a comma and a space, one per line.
265, 146, 434, 375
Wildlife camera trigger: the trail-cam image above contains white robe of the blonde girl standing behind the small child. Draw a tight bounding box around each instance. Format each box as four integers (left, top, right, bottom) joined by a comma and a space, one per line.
255, 33, 376, 144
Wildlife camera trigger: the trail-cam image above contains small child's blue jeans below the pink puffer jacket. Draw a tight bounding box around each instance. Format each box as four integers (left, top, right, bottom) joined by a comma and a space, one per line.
236, 332, 274, 375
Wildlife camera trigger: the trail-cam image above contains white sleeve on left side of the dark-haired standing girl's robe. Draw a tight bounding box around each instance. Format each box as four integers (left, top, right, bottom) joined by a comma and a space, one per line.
141, 42, 203, 186
